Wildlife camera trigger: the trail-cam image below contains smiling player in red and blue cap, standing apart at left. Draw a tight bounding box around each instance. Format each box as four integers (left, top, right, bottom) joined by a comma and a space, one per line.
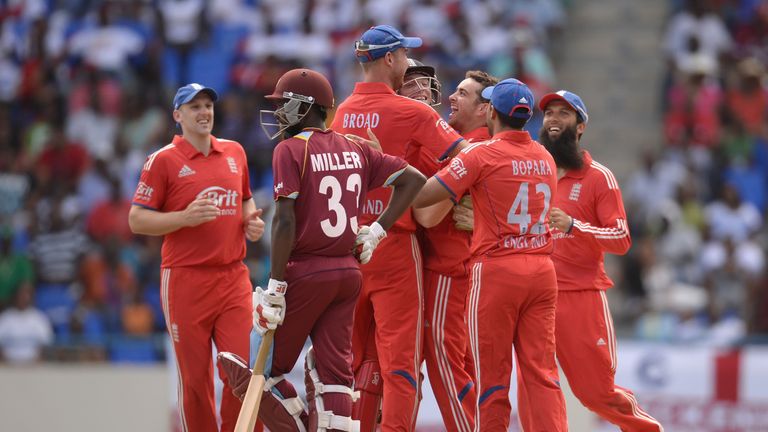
129, 84, 264, 432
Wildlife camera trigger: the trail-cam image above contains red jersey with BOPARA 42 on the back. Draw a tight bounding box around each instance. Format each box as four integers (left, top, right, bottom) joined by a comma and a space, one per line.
436, 131, 557, 257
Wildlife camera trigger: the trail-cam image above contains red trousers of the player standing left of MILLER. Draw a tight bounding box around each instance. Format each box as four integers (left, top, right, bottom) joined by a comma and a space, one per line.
160, 262, 253, 432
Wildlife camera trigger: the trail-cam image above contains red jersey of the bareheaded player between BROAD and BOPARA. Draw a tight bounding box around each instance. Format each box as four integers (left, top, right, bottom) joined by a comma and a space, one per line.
421, 127, 491, 276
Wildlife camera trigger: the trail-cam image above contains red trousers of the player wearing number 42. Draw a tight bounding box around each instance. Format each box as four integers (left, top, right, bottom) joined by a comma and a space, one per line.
467, 254, 568, 432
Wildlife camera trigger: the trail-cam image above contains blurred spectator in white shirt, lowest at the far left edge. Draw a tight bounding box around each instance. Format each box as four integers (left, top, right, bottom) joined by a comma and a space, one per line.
0, 283, 53, 364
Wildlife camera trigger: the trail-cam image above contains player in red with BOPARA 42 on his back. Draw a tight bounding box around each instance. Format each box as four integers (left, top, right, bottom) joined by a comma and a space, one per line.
414, 78, 567, 432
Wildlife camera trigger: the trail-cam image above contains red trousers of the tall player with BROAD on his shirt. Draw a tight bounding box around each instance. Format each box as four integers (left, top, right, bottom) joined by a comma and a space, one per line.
352, 231, 424, 432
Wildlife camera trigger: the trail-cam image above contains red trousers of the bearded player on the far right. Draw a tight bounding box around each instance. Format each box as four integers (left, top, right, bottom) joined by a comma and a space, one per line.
518, 289, 664, 432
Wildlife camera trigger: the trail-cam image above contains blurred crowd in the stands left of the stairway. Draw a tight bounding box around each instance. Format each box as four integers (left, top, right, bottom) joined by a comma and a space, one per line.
0, 0, 569, 362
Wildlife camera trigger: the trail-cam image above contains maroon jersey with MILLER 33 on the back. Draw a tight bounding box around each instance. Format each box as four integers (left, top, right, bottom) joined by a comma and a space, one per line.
272, 128, 407, 259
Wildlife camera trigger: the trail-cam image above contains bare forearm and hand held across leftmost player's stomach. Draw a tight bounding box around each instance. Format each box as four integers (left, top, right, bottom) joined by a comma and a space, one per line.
128, 198, 221, 235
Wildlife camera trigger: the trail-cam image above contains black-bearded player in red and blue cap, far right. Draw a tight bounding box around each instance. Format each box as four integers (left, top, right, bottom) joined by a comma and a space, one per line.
519, 90, 663, 432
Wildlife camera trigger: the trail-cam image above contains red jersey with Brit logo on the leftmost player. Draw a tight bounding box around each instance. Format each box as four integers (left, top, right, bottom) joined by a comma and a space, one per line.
133, 135, 251, 267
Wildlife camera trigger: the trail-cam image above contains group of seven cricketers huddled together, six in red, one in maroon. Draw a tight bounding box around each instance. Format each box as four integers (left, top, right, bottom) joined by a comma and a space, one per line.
130, 25, 663, 432
